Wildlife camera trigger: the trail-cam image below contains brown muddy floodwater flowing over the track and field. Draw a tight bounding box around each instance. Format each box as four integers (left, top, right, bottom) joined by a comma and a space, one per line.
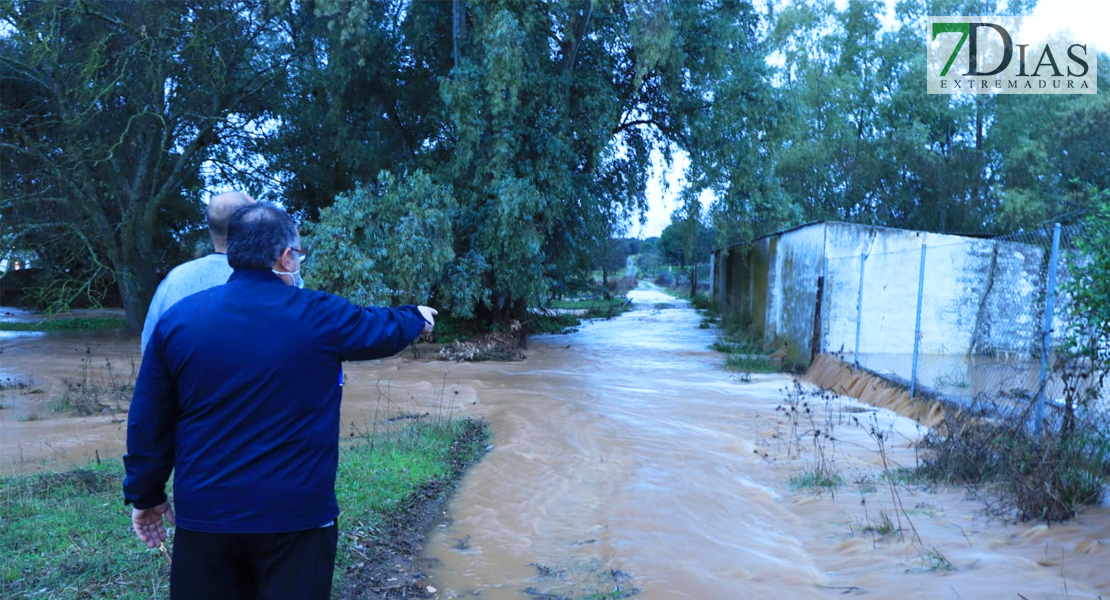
0, 289, 1110, 600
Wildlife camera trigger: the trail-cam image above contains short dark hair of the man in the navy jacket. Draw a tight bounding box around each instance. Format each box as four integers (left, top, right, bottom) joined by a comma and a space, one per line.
228, 202, 297, 268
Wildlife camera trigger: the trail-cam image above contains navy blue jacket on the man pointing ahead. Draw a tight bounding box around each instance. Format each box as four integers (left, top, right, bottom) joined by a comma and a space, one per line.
123, 270, 425, 533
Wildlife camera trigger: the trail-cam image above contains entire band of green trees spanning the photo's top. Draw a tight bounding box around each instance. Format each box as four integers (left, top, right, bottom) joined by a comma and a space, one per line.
0, 0, 1110, 328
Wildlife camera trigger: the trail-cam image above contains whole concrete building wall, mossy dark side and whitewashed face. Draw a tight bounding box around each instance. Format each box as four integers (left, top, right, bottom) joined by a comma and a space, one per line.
715, 222, 1046, 363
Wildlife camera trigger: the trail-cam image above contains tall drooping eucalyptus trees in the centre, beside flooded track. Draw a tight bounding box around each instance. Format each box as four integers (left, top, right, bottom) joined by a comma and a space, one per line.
279, 0, 781, 319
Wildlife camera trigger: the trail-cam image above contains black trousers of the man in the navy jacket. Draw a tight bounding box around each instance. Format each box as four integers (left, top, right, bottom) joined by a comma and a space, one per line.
170, 525, 337, 600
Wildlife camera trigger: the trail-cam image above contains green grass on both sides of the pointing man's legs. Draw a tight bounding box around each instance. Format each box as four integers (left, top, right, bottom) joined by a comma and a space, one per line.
0, 421, 486, 600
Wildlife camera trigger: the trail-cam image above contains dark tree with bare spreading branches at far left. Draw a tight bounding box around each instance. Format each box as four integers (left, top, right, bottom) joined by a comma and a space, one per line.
0, 0, 292, 330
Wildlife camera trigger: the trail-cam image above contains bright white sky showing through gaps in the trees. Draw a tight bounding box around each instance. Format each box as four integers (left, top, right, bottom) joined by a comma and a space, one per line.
626, 0, 1110, 238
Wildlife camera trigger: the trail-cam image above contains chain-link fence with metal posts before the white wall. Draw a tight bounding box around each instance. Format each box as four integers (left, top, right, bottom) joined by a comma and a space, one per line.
820, 221, 1106, 419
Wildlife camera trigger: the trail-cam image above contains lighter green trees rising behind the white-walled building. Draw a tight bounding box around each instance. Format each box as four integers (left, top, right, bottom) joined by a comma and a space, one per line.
765, 0, 1110, 233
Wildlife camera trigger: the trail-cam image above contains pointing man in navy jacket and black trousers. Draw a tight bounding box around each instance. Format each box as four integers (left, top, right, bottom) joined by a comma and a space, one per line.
123, 204, 436, 600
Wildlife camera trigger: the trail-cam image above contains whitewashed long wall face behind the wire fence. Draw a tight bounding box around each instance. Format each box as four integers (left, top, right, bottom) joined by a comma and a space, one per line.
825, 223, 1043, 356
